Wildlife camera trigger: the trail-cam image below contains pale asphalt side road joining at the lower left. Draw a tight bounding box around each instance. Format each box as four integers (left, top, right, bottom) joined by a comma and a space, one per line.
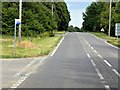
0, 57, 45, 90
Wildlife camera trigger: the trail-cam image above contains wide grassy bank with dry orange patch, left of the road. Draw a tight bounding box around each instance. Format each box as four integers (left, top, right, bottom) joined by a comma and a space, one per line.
0, 35, 62, 58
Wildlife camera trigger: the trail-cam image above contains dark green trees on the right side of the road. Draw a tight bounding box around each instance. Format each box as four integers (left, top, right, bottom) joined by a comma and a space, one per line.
81, 0, 120, 36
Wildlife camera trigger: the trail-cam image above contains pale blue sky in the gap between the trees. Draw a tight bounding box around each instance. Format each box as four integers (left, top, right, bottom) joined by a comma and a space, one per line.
65, 0, 95, 28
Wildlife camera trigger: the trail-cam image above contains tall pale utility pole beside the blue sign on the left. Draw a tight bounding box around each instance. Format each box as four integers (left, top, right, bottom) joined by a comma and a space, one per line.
18, 0, 22, 43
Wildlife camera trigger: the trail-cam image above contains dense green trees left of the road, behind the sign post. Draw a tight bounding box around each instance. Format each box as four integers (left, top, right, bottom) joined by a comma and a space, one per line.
2, 2, 70, 36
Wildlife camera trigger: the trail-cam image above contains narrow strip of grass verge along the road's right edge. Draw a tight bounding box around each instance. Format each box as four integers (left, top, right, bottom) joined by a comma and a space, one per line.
92, 32, 120, 47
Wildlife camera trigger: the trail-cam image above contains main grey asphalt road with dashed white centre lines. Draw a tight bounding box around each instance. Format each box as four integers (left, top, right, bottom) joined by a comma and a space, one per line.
1, 33, 120, 90
